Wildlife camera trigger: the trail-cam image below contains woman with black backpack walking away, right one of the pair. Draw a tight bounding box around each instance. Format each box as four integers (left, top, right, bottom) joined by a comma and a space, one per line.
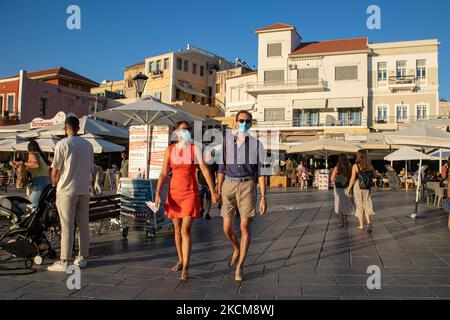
347, 150, 374, 230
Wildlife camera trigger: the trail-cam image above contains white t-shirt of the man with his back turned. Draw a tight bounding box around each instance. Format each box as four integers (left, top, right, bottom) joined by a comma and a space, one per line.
52, 136, 94, 196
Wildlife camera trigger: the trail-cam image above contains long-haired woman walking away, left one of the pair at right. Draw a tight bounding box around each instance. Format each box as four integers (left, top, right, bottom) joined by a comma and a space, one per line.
331, 154, 354, 228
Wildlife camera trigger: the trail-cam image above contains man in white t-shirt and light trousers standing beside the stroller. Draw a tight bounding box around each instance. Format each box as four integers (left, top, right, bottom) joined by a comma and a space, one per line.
47, 117, 94, 272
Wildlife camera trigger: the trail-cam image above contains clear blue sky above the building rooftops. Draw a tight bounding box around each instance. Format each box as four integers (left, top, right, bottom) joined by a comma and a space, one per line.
0, 0, 450, 99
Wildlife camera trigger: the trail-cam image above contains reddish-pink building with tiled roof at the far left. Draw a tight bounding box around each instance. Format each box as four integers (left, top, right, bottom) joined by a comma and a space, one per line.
0, 68, 108, 125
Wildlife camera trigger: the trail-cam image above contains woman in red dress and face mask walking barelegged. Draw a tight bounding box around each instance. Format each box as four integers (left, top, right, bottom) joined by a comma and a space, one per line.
155, 121, 219, 280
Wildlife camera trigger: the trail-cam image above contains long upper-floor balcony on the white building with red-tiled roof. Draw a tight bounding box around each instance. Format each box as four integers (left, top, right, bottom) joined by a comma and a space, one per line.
246, 79, 328, 96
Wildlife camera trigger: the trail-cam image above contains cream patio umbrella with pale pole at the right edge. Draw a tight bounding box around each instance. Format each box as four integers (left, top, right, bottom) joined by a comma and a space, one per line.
384, 124, 450, 218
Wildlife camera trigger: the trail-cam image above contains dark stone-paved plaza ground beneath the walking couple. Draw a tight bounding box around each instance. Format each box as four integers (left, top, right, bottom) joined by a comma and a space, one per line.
0, 189, 450, 300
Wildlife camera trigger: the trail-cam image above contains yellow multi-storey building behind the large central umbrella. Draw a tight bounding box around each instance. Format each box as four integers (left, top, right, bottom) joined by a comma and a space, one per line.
124, 45, 234, 118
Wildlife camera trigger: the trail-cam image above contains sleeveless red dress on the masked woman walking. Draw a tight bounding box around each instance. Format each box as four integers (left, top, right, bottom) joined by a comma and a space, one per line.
164, 144, 201, 219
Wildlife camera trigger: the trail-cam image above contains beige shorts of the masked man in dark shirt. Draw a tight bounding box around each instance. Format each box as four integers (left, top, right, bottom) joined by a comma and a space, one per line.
221, 179, 256, 218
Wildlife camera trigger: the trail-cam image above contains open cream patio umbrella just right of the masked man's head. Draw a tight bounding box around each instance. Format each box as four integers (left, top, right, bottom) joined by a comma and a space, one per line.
287, 139, 359, 168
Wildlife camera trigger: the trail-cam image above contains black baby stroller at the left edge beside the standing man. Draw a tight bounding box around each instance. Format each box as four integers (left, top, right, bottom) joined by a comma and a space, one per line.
0, 185, 59, 269
